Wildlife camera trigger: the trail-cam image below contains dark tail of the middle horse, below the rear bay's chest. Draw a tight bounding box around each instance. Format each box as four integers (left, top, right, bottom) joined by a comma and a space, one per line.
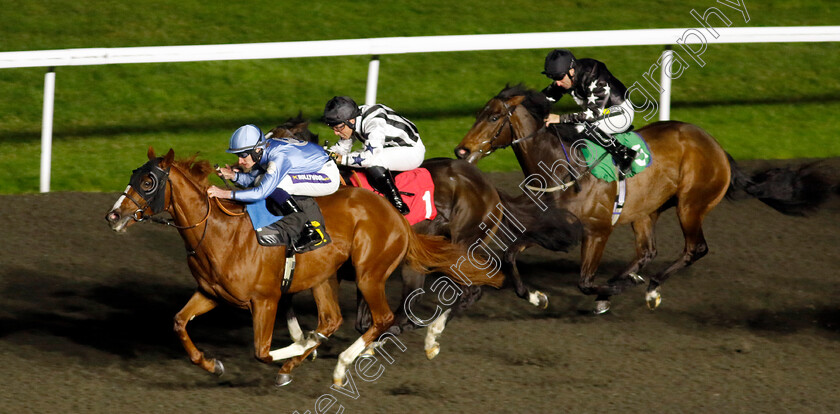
496, 189, 583, 252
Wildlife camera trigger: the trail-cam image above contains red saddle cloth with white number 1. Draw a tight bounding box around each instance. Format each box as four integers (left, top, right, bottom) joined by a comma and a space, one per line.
349, 168, 437, 225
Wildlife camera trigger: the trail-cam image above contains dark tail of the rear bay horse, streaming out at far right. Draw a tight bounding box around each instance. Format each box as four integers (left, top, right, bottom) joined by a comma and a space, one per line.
726, 153, 831, 216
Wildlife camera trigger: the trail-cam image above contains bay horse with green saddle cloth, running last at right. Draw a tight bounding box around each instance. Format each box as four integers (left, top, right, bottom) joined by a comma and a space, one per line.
455, 85, 825, 313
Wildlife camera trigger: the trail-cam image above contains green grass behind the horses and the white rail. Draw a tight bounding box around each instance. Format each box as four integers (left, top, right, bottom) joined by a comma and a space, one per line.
0, 0, 840, 194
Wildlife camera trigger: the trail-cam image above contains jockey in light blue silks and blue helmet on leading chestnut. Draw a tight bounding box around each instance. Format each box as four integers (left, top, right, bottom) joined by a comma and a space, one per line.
207, 124, 340, 250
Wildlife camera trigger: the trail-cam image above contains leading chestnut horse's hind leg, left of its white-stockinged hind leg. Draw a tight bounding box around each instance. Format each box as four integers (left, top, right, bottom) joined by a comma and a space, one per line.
275, 277, 343, 386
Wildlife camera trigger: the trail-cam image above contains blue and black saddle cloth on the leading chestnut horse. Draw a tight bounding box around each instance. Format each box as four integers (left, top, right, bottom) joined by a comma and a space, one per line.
245, 196, 331, 253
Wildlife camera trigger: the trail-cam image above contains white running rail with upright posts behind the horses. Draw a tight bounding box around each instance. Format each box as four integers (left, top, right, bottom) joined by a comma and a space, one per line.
0, 26, 840, 192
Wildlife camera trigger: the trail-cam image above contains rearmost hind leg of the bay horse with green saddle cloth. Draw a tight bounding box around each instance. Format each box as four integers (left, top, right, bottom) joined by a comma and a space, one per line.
645, 206, 710, 310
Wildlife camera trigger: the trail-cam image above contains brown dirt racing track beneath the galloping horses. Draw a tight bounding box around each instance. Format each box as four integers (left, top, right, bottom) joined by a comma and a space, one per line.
0, 159, 840, 414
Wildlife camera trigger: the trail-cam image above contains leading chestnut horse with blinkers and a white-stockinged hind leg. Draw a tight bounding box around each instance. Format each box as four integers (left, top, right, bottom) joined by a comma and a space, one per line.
106, 148, 502, 386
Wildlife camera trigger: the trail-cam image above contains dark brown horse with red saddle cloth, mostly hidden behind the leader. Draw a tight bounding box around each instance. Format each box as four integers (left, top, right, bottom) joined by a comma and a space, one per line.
266, 117, 581, 359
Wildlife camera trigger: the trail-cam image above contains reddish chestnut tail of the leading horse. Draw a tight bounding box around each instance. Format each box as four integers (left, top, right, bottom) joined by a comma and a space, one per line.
405, 226, 504, 289
